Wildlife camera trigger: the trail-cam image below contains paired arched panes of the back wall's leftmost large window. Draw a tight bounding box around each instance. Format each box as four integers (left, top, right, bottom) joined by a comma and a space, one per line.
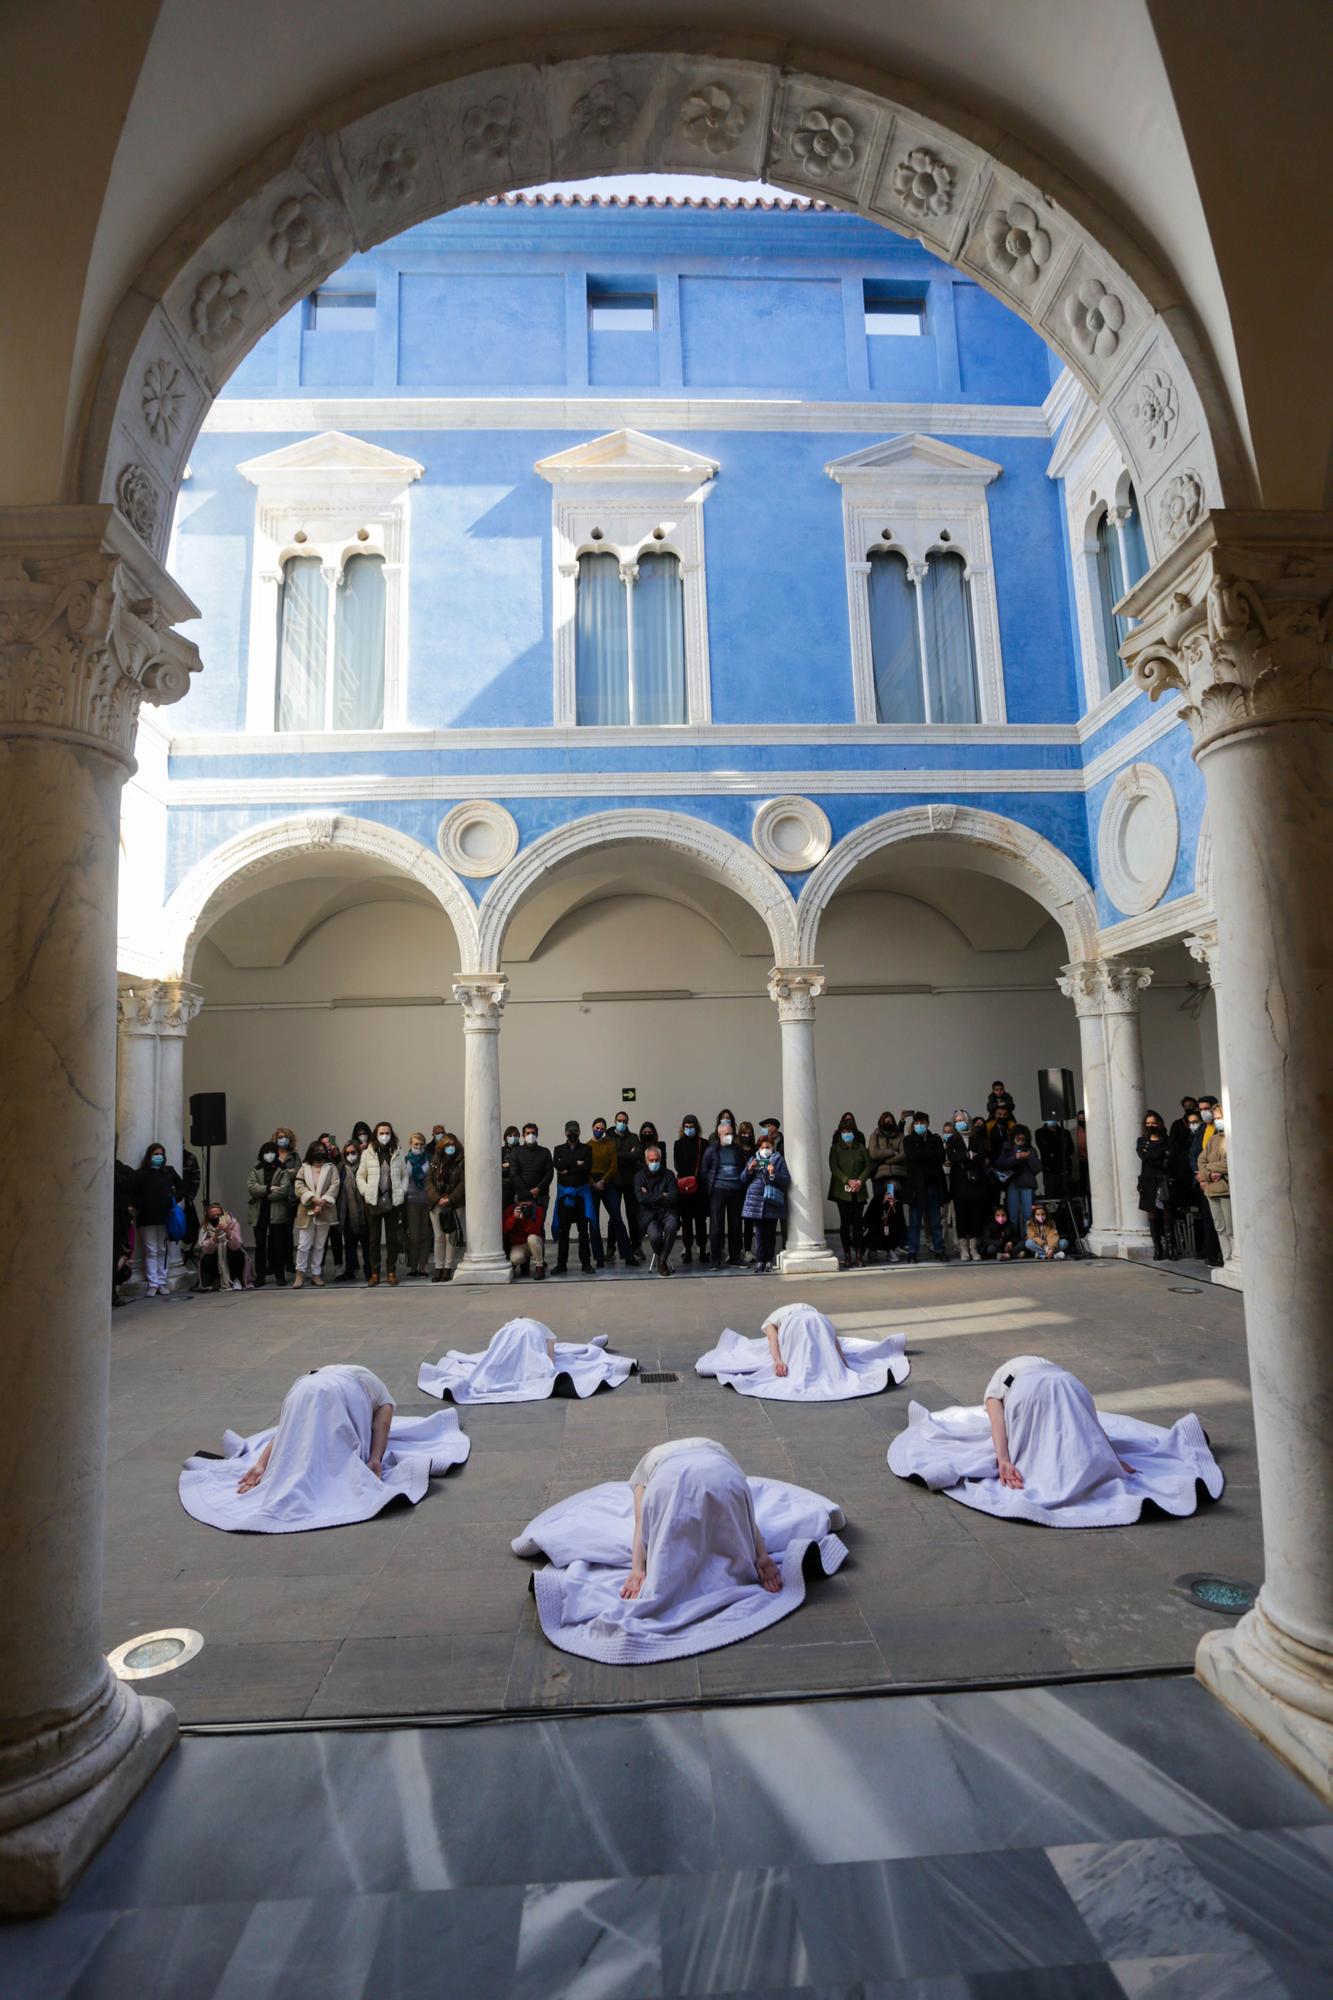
276, 556, 384, 730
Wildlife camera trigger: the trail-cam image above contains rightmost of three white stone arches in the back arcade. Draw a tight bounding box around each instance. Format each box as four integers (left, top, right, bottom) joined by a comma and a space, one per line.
797, 806, 1097, 964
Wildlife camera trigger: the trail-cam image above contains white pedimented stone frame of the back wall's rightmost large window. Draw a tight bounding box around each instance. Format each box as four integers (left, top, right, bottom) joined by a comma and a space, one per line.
825, 434, 1007, 728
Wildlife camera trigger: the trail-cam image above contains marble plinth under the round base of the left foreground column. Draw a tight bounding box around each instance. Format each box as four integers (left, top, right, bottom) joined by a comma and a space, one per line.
0, 1688, 180, 1916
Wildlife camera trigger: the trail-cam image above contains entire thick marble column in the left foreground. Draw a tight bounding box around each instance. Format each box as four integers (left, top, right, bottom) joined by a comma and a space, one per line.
0, 506, 198, 1914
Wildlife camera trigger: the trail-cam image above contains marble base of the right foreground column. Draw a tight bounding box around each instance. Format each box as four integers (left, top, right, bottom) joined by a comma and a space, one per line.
1195, 1598, 1333, 1804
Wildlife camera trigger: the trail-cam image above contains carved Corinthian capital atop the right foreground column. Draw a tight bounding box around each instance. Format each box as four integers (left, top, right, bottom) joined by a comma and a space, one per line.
1123, 512, 1333, 754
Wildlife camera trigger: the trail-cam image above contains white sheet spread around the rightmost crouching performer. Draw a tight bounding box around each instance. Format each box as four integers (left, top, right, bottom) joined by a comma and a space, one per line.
889, 1364, 1223, 1528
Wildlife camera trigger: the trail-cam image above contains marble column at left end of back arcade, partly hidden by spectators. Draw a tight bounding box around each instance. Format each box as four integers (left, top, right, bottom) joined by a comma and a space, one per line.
116, 978, 204, 1292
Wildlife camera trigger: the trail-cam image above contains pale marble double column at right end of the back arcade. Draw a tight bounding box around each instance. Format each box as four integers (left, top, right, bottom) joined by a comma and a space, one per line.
1057, 958, 1153, 1256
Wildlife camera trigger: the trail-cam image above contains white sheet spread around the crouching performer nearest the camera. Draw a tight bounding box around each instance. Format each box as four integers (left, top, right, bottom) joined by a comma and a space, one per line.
512, 1448, 847, 1666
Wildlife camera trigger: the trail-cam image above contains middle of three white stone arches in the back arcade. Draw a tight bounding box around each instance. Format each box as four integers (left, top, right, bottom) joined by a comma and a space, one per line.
476, 810, 797, 972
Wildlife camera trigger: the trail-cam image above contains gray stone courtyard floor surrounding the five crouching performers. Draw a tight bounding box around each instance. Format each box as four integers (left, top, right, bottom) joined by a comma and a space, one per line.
104, 1262, 1261, 1722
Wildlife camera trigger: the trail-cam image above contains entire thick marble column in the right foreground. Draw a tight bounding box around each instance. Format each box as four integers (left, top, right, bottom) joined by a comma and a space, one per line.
1121, 512, 1333, 1798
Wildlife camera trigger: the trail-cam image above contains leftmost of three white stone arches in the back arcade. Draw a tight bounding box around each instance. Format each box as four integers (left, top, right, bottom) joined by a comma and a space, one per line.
162, 812, 478, 980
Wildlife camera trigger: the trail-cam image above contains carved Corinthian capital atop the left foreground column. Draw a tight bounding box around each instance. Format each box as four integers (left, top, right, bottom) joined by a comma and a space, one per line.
0, 506, 200, 764
